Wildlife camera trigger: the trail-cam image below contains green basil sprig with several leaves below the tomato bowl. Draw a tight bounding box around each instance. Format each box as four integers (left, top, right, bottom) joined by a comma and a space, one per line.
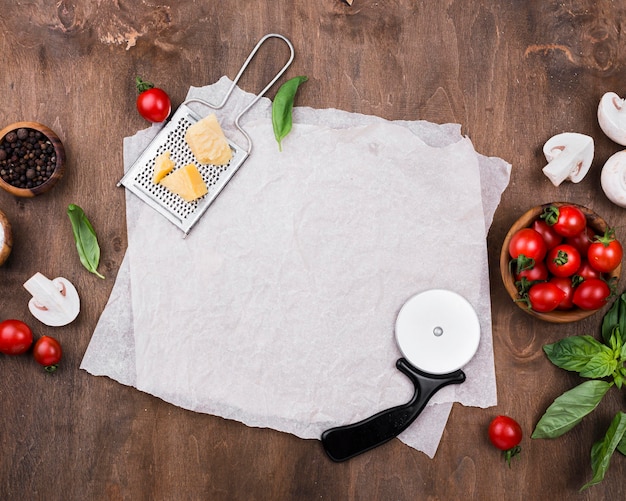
532, 293, 626, 491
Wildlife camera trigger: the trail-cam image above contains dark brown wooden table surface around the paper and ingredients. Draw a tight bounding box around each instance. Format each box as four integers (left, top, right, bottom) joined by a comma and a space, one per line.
0, 0, 626, 500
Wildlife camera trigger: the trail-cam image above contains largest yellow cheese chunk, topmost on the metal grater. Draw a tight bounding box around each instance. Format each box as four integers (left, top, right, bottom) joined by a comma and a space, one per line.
185, 113, 233, 165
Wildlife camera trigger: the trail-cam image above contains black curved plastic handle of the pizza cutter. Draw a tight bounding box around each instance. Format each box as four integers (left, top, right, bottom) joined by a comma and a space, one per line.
322, 358, 465, 462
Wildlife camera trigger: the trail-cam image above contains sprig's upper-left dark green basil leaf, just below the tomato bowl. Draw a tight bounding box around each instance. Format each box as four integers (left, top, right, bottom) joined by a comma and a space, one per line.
543, 336, 615, 377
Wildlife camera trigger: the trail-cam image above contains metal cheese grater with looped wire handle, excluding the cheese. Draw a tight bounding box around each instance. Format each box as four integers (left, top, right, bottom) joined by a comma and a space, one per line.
117, 33, 295, 235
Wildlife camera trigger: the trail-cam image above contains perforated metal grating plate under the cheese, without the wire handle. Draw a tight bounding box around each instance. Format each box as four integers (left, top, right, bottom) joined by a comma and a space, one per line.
120, 104, 248, 234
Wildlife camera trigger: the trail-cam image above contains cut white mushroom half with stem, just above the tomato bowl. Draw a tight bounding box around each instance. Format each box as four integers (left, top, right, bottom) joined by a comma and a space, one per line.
543, 132, 594, 186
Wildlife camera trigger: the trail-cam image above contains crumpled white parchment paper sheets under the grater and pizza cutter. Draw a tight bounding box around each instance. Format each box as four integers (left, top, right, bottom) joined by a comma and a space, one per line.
81, 77, 510, 457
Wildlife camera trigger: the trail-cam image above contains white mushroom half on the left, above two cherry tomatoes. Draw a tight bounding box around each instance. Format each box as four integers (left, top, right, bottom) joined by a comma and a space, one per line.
24, 272, 80, 327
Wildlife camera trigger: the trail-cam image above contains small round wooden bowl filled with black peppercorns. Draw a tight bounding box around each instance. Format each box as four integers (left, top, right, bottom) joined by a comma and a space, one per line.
0, 122, 65, 197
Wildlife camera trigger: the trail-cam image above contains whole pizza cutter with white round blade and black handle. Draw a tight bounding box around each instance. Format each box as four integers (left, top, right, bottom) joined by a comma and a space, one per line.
322, 289, 480, 461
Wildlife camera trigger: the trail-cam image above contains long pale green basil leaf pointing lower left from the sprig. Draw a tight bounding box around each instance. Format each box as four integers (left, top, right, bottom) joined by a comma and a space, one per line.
532, 380, 613, 438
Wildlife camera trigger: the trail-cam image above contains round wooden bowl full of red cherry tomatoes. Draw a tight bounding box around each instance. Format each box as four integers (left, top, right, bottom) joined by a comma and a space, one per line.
500, 202, 623, 323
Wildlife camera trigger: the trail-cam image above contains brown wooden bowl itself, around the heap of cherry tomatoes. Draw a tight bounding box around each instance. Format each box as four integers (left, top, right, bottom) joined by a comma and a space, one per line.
500, 202, 622, 324
